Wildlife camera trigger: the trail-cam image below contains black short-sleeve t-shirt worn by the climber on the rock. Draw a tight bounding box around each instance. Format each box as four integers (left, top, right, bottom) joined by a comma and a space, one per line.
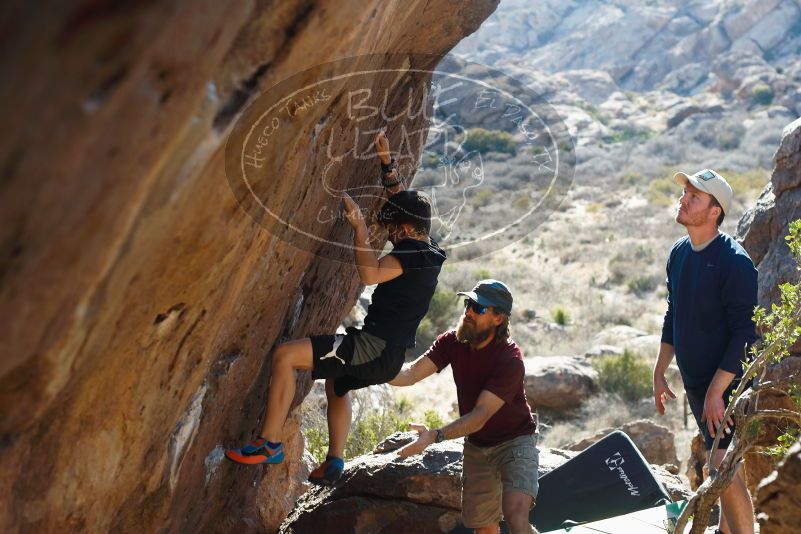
364, 239, 446, 348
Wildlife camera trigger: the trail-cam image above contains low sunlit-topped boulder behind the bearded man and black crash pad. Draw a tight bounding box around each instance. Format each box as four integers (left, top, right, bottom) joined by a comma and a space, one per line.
280, 433, 688, 534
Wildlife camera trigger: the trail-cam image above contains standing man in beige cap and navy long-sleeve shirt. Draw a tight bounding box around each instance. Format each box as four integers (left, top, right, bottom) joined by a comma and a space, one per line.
654, 169, 757, 534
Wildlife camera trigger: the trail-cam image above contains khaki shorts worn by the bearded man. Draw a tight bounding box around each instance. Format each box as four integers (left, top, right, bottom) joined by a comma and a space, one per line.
462, 434, 540, 528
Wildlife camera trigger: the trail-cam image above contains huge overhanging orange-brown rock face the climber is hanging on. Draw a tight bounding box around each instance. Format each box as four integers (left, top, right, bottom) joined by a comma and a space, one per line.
0, 0, 497, 532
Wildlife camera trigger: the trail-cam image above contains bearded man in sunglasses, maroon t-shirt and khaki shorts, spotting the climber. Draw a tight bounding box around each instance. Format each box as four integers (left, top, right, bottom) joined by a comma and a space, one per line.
390, 280, 539, 534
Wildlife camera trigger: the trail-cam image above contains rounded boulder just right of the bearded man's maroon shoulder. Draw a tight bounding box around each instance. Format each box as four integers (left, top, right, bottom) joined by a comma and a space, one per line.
524, 356, 598, 413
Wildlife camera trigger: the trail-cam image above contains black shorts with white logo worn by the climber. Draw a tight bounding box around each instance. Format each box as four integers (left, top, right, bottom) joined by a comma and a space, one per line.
310, 328, 406, 397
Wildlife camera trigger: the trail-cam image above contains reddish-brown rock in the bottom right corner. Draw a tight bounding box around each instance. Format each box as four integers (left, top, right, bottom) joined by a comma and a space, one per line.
756, 442, 801, 534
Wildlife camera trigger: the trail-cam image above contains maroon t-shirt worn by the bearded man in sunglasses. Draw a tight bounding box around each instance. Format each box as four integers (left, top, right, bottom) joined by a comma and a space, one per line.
423, 330, 536, 447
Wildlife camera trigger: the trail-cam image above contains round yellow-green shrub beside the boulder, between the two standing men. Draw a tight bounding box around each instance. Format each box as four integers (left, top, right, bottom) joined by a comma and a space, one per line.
592, 350, 653, 401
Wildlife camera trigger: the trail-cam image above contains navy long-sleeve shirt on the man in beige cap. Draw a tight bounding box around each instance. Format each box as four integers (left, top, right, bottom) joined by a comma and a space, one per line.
662, 233, 757, 387
